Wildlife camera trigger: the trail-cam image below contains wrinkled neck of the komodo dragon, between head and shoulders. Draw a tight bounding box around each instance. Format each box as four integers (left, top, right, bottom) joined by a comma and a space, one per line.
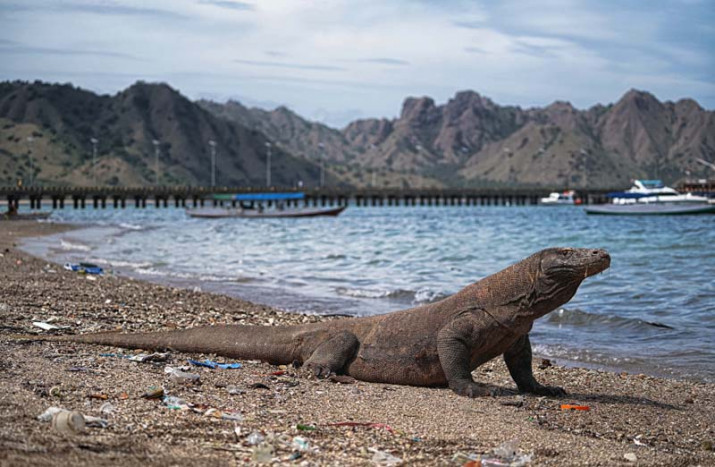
464, 255, 585, 328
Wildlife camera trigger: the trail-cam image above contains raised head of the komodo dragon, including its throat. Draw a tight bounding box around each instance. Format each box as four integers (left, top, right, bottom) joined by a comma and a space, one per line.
530, 248, 611, 318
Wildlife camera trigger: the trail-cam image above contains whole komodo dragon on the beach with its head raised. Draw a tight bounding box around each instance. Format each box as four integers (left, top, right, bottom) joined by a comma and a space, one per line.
44, 248, 611, 397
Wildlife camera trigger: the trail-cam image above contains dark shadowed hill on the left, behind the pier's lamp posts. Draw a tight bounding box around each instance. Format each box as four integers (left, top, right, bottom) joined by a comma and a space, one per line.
0, 82, 336, 186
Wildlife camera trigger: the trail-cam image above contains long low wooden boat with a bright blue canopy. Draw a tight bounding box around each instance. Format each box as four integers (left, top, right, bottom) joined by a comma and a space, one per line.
186, 193, 347, 219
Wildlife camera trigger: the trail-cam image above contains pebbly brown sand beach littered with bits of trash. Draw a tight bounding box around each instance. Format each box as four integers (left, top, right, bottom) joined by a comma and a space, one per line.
0, 221, 715, 466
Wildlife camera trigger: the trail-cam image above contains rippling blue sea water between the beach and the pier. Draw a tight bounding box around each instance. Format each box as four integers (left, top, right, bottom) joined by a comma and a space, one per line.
25, 206, 715, 382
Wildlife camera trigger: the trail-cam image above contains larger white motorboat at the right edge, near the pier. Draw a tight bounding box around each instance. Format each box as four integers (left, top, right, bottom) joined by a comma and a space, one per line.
584, 180, 715, 216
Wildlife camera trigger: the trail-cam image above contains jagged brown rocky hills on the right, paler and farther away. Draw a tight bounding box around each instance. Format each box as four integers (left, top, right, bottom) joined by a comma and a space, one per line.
202, 90, 715, 187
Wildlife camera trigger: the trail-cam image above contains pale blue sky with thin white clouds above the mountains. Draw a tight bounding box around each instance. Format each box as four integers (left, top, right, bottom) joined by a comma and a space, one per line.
0, 0, 715, 127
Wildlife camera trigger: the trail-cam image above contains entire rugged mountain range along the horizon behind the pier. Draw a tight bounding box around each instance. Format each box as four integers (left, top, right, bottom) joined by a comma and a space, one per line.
0, 81, 715, 188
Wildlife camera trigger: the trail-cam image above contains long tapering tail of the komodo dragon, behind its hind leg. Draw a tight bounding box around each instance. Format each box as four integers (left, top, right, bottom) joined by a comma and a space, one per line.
16, 325, 296, 364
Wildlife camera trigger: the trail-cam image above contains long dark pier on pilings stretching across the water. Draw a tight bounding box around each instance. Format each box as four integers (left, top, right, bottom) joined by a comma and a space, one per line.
0, 186, 613, 210
